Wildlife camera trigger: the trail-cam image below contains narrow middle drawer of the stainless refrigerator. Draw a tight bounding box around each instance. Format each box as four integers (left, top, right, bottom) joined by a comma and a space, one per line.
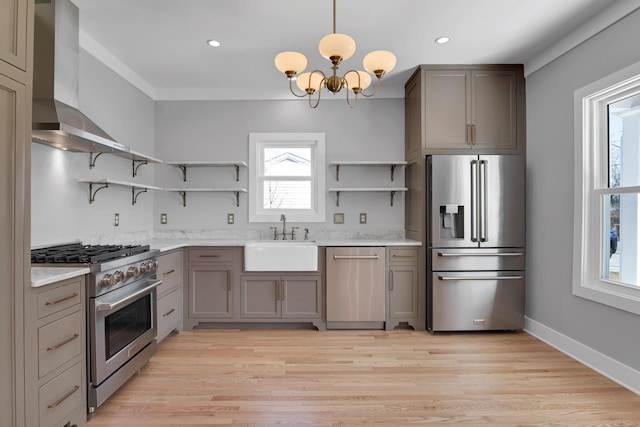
430, 248, 524, 271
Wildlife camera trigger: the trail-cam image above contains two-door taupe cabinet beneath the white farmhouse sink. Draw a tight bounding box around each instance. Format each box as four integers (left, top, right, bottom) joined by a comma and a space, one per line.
240, 275, 322, 320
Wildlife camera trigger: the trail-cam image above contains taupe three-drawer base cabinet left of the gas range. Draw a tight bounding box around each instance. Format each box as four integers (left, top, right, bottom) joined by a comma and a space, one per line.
25, 276, 87, 427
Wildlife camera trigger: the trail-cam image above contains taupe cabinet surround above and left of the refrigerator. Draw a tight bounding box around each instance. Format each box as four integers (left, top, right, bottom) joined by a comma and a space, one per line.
405, 64, 525, 332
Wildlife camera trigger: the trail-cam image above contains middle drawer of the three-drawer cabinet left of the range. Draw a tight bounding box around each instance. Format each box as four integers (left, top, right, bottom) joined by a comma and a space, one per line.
38, 311, 85, 378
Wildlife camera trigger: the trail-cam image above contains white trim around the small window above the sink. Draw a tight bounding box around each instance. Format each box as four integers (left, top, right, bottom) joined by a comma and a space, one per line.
249, 133, 326, 222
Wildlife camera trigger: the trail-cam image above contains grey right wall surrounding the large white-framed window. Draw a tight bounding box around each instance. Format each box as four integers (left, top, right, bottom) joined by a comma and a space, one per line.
526, 11, 640, 370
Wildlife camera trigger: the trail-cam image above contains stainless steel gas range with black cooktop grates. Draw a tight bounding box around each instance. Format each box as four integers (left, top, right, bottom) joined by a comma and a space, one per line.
31, 243, 162, 413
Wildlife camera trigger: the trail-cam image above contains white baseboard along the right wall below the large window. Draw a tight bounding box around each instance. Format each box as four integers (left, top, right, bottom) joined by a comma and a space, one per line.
524, 317, 640, 395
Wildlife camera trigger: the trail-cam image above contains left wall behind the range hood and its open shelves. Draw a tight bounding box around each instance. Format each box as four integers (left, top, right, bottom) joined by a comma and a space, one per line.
31, 50, 154, 246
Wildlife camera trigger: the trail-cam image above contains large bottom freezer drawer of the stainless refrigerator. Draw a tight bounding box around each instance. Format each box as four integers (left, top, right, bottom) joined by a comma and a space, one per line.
431, 271, 524, 331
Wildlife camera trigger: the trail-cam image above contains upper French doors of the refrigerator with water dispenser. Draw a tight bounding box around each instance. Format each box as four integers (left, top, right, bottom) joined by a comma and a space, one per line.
427, 155, 525, 248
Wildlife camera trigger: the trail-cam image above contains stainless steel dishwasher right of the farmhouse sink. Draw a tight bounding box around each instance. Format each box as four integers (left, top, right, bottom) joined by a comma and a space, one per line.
326, 247, 386, 329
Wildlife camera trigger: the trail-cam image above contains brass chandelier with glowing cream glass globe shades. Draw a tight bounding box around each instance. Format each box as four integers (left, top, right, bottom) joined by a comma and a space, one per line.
275, 0, 396, 108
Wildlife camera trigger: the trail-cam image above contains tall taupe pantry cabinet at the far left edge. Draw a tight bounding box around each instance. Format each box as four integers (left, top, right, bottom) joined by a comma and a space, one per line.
0, 0, 33, 426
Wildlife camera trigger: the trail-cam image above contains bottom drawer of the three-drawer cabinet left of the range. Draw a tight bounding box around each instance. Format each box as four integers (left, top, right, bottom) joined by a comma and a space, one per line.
38, 363, 84, 427
